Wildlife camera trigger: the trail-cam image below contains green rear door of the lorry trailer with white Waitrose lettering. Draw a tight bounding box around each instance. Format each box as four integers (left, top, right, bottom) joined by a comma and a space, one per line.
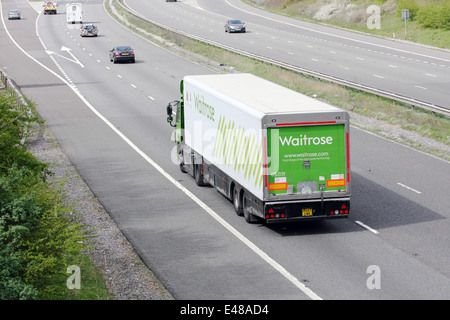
266, 124, 349, 197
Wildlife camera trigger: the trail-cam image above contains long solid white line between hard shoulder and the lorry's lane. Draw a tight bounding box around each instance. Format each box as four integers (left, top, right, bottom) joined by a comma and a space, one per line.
0, 0, 322, 300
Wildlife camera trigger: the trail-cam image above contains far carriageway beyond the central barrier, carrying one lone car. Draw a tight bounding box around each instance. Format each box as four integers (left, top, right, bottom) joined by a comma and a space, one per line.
126, 0, 450, 109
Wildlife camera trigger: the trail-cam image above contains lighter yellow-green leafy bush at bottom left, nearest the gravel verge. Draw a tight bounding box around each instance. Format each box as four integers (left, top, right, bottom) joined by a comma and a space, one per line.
19, 184, 87, 299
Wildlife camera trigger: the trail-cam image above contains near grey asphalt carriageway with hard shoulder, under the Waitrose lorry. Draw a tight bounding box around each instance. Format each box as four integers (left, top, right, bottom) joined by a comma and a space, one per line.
0, 0, 450, 300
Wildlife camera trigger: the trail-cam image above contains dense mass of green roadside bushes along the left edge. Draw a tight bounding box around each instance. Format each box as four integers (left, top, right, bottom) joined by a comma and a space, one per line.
0, 91, 86, 300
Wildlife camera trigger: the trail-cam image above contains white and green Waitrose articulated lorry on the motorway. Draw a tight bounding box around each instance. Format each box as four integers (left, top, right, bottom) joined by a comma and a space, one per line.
167, 74, 351, 223
